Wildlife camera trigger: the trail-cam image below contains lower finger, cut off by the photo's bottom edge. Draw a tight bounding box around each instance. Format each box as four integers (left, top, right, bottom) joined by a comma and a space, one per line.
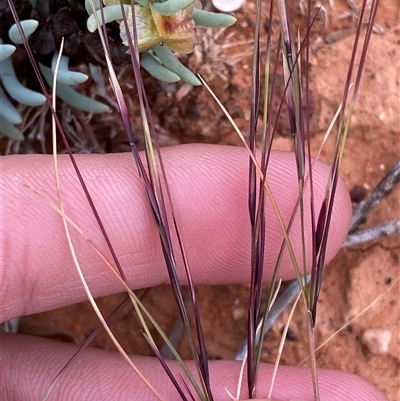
0, 334, 387, 401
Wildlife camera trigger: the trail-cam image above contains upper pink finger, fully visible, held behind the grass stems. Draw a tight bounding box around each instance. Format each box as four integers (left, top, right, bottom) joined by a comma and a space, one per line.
1, 145, 351, 321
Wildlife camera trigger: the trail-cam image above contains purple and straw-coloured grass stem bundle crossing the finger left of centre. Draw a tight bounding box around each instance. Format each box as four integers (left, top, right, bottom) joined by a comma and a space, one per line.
88, 3, 213, 400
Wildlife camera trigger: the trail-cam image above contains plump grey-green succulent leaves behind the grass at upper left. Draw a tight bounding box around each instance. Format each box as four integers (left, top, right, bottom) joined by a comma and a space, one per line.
0, 0, 236, 140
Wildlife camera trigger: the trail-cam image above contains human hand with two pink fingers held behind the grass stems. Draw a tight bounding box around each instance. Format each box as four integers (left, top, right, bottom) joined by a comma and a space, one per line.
1, 145, 386, 401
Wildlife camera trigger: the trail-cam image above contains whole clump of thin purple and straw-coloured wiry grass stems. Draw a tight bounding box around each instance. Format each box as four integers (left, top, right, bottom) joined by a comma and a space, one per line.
2, 0, 396, 400
